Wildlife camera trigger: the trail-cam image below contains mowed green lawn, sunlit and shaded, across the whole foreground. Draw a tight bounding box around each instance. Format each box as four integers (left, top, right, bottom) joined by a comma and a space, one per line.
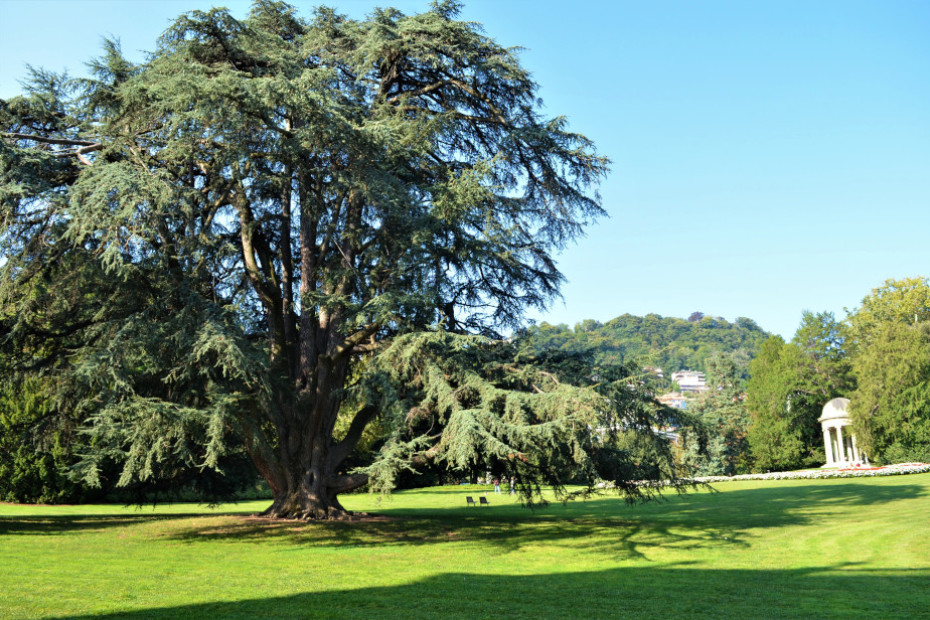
0, 474, 930, 619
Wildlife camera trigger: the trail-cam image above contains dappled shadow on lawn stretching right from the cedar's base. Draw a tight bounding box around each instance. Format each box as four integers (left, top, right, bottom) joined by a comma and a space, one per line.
156, 483, 926, 559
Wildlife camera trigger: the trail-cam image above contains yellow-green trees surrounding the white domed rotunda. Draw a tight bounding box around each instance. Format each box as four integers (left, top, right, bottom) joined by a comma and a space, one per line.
708, 277, 930, 473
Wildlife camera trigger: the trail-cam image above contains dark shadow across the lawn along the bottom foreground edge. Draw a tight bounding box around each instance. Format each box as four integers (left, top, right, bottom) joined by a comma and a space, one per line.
59, 566, 930, 620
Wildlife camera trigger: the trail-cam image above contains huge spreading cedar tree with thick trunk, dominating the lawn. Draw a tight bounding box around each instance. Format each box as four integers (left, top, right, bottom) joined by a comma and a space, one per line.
0, 0, 680, 518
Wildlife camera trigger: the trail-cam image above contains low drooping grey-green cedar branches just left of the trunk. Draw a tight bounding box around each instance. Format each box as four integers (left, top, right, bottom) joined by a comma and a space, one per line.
67, 293, 268, 486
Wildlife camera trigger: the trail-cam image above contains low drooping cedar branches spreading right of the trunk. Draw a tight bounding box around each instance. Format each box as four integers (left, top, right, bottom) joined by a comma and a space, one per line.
358, 332, 675, 504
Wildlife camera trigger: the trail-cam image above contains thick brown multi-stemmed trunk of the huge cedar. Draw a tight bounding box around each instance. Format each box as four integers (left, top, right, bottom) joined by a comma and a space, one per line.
245, 149, 380, 519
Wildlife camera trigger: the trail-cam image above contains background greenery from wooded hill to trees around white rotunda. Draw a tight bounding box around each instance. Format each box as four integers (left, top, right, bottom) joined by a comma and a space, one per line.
526, 277, 930, 475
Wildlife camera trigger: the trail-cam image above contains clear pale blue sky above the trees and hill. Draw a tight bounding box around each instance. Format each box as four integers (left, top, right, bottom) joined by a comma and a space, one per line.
0, 0, 930, 337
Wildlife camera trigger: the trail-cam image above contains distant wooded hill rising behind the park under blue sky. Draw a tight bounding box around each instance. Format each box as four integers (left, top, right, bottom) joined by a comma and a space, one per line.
526, 312, 771, 377
